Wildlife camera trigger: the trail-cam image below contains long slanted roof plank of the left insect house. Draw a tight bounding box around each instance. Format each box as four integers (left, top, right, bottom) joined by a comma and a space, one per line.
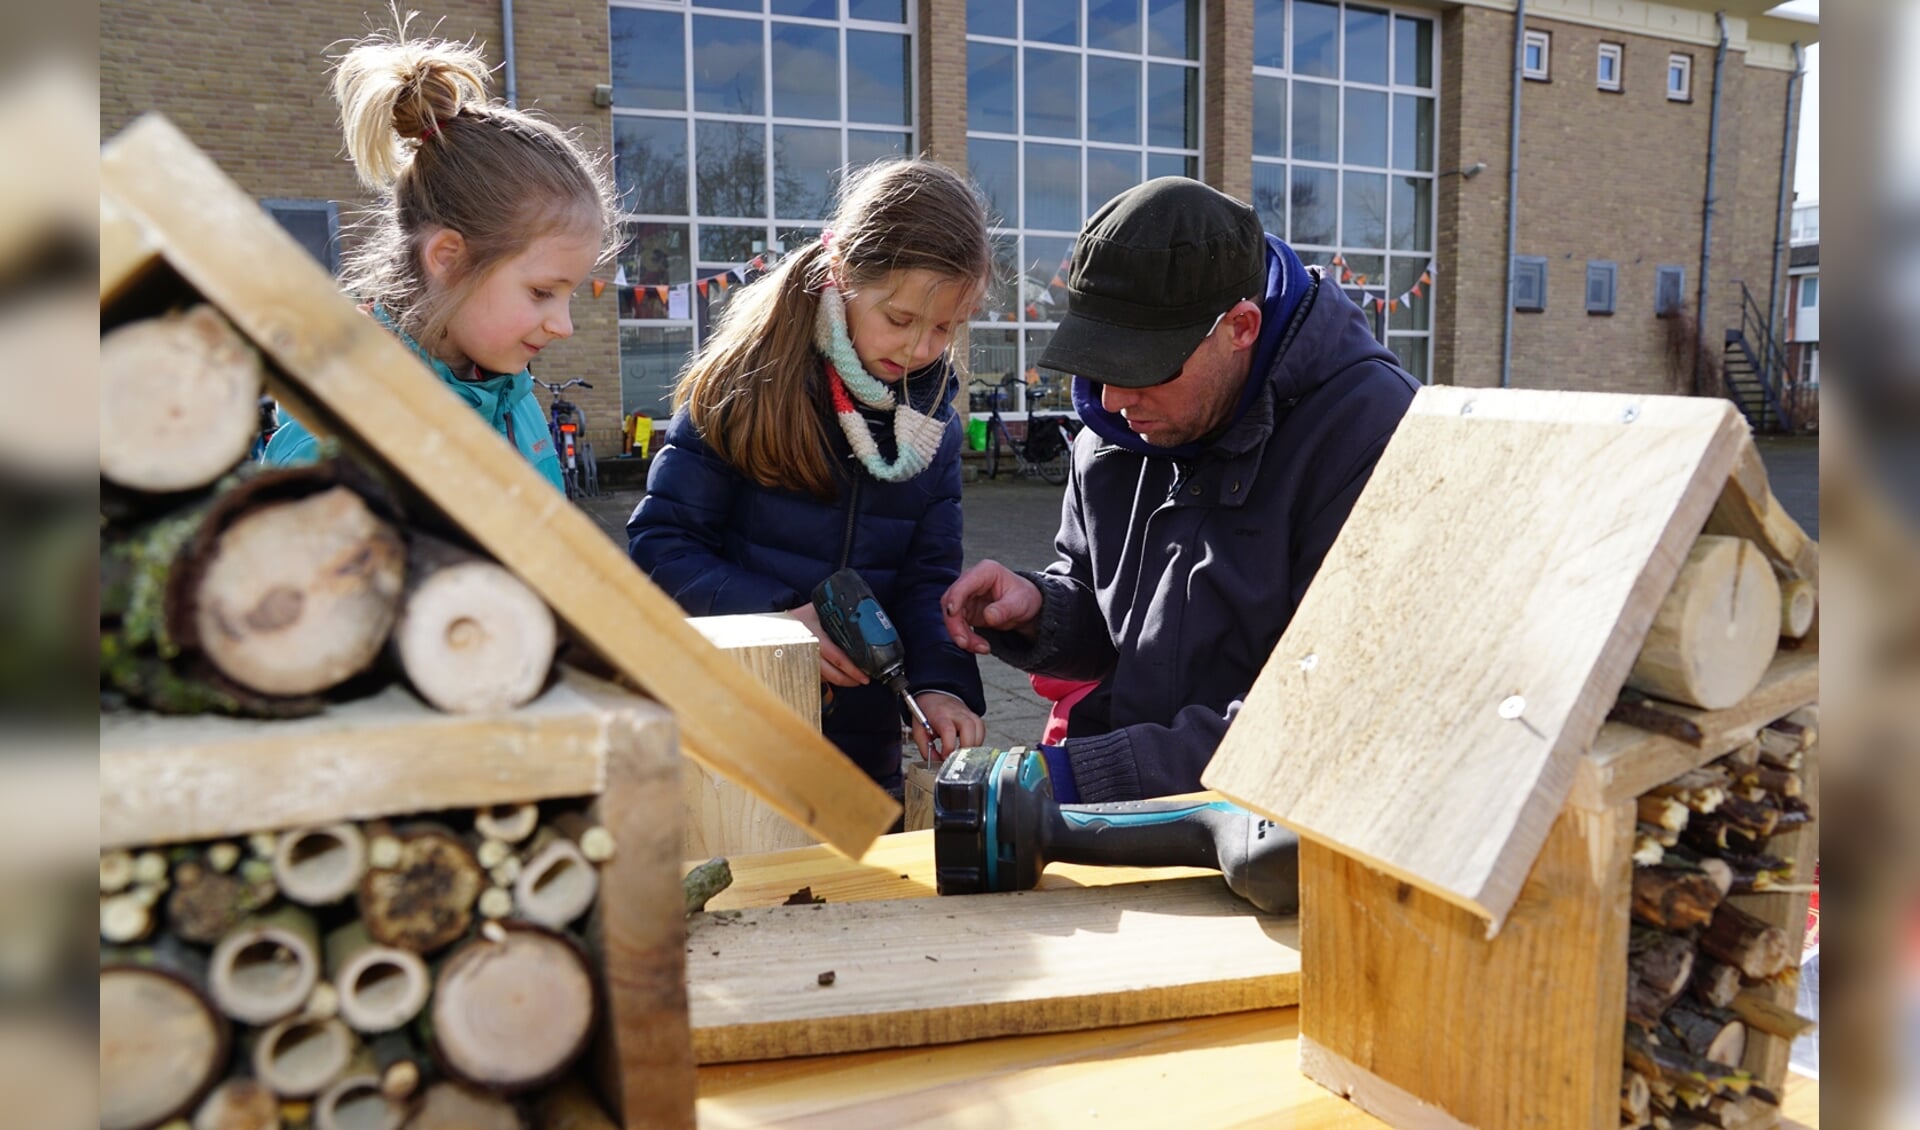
100, 115, 900, 856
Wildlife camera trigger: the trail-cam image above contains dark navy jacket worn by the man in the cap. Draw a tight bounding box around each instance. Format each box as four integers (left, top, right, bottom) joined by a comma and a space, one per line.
983, 251, 1417, 802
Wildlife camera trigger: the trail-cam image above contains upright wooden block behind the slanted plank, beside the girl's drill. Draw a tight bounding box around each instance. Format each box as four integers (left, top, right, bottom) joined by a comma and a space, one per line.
680, 616, 820, 859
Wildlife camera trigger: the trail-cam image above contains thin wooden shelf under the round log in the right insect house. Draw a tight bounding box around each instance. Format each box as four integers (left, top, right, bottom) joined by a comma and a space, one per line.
1567, 650, 1820, 812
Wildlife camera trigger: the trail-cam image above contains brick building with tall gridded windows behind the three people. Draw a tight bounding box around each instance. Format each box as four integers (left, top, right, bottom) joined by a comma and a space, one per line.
102, 0, 1818, 443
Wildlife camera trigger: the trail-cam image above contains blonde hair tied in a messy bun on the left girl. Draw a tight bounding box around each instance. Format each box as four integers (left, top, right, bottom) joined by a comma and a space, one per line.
334, 12, 618, 349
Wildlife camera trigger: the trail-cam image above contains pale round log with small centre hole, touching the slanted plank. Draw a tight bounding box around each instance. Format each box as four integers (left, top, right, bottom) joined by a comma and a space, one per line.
394, 533, 559, 714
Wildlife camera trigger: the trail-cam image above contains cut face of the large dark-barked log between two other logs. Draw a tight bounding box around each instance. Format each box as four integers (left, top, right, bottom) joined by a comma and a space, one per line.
194, 487, 405, 696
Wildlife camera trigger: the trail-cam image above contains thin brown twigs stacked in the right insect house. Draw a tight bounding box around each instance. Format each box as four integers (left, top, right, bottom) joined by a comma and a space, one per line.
1620, 714, 1816, 1130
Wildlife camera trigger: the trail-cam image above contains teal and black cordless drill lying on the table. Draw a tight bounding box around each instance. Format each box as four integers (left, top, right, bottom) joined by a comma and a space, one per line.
933, 746, 1300, 915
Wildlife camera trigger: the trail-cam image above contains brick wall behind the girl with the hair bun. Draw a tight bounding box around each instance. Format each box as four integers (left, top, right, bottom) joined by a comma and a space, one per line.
100, 0, 620, 455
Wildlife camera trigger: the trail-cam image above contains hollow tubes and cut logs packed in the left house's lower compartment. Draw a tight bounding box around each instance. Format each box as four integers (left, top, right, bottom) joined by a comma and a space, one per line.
100, 802, 614, 1130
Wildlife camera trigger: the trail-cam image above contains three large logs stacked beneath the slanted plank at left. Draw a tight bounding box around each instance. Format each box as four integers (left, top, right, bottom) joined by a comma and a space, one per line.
100, 305, 557, 717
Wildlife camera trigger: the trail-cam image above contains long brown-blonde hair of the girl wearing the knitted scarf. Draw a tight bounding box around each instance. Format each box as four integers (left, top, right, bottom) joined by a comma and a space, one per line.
674, 157, 993, 497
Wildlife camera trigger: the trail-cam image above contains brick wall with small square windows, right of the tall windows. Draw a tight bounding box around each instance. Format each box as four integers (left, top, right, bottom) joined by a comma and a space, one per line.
1434, 8, 1788, 393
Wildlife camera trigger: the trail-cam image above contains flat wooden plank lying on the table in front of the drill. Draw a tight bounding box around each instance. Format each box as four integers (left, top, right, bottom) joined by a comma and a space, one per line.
687, 877, 1300, 1063
